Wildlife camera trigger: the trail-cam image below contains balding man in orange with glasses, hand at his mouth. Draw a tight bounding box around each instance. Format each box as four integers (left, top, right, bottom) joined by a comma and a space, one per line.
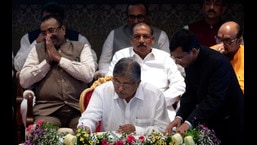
211, 21, 244, 93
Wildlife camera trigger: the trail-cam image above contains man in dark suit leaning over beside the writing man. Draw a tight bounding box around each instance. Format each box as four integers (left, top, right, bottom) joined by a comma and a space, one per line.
166, 29, 244, 145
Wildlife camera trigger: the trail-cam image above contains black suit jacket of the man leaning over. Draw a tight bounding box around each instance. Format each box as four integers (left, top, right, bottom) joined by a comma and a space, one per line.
177, 46, 244, 144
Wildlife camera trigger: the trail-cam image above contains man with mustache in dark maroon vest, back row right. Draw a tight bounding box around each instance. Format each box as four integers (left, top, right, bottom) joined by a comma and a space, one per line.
184, 0, 227, 47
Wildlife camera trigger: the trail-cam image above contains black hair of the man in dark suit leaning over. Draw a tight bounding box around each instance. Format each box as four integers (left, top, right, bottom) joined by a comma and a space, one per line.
170, 29, 200, 53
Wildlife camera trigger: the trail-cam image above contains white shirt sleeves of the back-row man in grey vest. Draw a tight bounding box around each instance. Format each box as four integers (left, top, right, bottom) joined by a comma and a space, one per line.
99, 30, 170, 75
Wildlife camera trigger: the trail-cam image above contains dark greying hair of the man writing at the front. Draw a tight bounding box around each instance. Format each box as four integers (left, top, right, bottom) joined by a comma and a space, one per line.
113, 57, 141, 82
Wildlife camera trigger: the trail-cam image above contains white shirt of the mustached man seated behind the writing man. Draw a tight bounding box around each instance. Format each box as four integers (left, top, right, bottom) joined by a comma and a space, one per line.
107, 47, 186, 120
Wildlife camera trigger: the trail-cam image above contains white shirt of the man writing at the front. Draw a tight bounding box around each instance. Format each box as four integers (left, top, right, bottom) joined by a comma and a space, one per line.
78, 81, 170, 135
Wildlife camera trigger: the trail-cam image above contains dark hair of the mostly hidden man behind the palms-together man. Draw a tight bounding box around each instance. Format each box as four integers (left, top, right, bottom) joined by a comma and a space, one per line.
41, 1, 64, 19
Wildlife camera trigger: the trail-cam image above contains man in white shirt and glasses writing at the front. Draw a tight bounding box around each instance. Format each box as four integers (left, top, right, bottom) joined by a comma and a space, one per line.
78, 58, 169, 134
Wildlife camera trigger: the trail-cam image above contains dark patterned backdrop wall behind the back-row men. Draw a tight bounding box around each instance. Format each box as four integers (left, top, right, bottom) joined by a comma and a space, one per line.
11, 0, 244, 59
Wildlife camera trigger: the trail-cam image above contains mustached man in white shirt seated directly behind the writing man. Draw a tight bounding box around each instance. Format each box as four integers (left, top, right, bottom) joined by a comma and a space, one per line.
107, 22, 185, 120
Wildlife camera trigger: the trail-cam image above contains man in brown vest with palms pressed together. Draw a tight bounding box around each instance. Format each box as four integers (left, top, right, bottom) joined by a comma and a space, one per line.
20, 15, 96, 131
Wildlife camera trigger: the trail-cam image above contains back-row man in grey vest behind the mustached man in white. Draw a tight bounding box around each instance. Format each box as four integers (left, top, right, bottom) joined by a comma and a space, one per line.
95, 2, 170, 78
